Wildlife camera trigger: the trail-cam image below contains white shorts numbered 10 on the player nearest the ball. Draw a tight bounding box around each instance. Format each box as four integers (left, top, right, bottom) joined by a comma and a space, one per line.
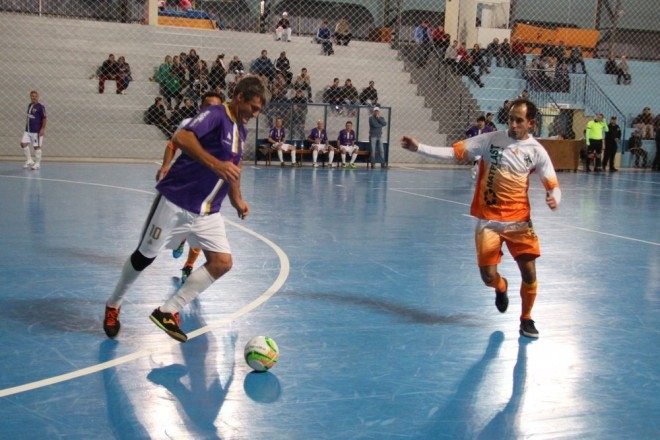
138, 195, 231, 258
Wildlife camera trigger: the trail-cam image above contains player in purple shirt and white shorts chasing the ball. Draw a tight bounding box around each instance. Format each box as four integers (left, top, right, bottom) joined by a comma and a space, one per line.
103, 77, 267, 342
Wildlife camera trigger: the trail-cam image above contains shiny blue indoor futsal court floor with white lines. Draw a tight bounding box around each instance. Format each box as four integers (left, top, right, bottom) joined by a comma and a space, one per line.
0, 162, 660, 440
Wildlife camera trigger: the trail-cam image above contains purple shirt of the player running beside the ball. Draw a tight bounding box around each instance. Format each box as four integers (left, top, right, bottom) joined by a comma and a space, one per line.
156, 104, 247, 214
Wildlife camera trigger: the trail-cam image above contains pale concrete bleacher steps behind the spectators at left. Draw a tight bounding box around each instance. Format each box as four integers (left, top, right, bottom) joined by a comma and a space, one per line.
0, 13, 445, 162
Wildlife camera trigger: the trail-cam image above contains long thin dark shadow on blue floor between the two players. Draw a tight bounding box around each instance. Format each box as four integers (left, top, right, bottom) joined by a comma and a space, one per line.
280, 292, 483, 327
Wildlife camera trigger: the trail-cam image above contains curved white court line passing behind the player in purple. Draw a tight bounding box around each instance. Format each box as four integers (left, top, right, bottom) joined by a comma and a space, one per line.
0, 176, 290, 398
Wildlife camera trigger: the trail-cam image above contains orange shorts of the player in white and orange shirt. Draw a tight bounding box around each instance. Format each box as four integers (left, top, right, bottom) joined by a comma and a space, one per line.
474, 220, 541, 267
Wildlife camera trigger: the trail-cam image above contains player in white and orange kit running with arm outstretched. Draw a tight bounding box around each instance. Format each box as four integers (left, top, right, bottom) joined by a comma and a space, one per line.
401, 99, 561, 338
